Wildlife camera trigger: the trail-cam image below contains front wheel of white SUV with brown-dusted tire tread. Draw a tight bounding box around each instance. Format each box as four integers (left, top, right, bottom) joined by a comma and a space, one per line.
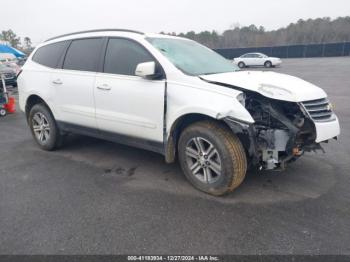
178, 121, 247, 196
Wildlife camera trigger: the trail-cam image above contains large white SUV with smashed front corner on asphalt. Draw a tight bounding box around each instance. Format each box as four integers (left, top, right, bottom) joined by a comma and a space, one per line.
18, 30, 340, 195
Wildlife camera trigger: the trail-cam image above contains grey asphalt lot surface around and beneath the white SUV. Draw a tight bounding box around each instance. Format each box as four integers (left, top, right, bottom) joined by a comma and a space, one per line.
0, 58, 350, 254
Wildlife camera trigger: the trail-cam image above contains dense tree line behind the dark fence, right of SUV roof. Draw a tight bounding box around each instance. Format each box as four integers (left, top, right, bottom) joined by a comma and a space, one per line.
163, 16, 350, 49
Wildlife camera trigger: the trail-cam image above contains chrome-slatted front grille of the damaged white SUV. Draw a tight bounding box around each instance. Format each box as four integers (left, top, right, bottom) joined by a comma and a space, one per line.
302, 98, 334, 121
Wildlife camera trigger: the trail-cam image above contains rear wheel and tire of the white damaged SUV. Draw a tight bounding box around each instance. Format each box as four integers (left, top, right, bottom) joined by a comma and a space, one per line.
28, 104, 62, 151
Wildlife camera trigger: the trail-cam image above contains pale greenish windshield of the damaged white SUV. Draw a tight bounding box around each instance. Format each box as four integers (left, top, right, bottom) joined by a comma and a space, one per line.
146, 37, 239, 75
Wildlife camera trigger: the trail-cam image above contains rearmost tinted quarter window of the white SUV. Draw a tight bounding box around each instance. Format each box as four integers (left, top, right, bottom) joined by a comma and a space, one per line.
32, 41, 67, 68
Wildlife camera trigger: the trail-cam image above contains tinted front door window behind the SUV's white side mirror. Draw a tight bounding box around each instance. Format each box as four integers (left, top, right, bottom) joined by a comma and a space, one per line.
104, 38, 154, 75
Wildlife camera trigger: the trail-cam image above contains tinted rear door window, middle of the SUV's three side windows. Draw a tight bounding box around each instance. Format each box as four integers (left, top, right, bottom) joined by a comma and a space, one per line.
63, 38, 103, 72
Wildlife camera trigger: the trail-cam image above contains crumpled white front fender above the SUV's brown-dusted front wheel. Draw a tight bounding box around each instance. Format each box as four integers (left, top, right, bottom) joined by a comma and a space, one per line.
164, 81, 254, 162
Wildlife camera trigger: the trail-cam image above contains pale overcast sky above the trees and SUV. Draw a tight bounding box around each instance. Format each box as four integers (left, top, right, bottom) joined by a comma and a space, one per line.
0, 0, 350, 44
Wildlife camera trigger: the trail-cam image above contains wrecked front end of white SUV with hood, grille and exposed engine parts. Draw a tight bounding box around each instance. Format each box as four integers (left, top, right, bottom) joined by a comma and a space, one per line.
201, 74, 339, 170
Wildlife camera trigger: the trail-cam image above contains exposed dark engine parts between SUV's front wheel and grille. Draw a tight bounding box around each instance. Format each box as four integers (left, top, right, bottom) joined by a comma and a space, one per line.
246, 95, 320, 169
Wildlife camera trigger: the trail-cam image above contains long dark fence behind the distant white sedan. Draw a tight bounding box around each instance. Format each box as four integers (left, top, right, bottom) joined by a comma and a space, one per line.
215, 42, 350, 59
